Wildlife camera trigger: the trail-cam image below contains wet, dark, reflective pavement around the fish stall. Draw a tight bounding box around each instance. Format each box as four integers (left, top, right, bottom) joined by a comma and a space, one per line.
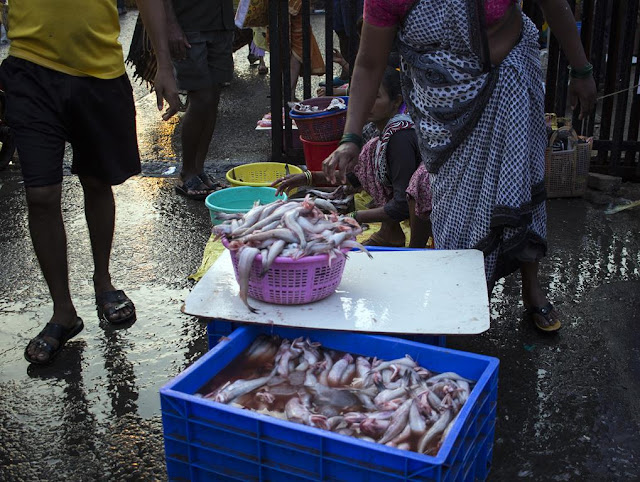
0, 8, 640, 481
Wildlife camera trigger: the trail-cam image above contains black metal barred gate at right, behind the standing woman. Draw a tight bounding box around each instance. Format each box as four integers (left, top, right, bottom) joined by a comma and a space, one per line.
524, 0, 640, 181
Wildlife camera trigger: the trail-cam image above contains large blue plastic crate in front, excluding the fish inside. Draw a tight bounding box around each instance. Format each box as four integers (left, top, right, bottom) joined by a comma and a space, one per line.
160, 325, 499, 482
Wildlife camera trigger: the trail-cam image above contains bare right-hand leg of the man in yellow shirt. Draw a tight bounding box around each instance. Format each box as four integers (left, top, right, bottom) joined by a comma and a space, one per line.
80, 176, 133, 322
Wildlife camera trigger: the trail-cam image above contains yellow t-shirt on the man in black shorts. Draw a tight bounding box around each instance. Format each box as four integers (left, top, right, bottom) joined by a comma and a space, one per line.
8, 0, 125, 79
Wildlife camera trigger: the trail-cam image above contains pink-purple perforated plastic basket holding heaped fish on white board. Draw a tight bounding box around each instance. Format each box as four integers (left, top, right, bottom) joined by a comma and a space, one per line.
223, 241, 346, 305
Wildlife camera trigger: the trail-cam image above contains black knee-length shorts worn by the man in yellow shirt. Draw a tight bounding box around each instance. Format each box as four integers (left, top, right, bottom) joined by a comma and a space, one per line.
0, 57, 140, 187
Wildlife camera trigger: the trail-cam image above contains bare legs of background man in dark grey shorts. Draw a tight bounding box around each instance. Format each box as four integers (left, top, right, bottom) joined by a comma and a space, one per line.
180, 85, 220, 194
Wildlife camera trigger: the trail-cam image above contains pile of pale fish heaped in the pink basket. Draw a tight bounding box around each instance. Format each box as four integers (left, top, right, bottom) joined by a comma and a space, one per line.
213, 196, 370, 313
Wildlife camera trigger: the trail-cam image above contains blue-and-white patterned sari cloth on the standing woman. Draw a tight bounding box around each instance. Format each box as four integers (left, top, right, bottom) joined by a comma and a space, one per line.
400, 0, 546, 284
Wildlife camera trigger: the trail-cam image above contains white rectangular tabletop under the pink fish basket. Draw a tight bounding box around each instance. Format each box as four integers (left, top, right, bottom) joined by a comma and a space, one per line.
184, 250, 489, 335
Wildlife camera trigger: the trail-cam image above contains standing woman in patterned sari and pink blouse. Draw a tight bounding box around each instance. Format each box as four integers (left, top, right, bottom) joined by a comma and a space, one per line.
323, 0, 596, 331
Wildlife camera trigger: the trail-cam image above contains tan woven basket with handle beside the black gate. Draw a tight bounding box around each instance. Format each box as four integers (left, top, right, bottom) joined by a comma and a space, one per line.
544, 127, 591, 198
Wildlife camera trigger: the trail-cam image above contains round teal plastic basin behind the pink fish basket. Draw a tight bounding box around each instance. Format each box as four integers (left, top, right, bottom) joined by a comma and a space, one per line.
204, 186, 287, 224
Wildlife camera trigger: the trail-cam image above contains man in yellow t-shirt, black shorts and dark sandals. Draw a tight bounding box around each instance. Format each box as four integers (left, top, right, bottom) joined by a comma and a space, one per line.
0, 0, 180, 364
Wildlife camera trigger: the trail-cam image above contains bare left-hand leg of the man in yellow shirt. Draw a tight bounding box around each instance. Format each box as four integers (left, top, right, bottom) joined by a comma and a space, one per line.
26, 184, 77, 361
